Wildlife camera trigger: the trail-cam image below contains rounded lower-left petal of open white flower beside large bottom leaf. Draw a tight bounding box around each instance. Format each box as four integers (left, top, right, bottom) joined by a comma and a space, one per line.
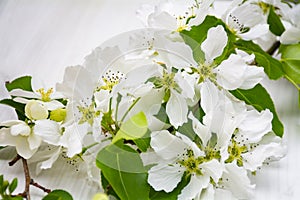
148, 163, 184, 192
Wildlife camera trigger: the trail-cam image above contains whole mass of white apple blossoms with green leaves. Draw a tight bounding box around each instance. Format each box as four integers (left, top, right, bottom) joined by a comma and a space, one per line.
0, 0, 300, 200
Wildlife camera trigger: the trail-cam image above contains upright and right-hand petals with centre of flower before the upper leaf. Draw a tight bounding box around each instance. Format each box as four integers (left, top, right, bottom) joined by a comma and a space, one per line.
198, 25, 264, 90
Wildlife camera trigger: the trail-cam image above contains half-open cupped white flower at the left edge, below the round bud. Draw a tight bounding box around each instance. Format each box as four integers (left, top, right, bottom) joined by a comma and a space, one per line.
0, 120, 41, 159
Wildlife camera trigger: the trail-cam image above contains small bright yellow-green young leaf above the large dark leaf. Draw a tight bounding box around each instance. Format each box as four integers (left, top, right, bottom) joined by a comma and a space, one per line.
112, 112, 148, 143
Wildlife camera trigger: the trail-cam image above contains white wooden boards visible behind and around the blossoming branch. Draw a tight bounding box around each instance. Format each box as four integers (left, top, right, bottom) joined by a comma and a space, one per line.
0, 0, 300, 200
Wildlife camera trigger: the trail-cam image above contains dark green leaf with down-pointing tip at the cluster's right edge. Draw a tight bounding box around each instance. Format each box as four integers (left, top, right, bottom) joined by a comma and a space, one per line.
230, 84, 284, 137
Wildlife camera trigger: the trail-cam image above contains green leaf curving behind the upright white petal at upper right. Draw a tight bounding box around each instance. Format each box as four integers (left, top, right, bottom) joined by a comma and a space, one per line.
180, 16, 236, 64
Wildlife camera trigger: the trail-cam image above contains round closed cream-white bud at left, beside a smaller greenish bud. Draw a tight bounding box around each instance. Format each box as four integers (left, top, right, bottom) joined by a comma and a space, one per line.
25, 100, 49, 120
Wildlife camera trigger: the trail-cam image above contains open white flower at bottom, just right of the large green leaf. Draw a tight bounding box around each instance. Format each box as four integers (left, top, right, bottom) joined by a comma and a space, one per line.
148, 131, 223, 200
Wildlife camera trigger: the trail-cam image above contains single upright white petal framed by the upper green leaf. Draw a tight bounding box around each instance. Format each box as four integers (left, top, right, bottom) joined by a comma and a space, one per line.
201, 25, 228, 63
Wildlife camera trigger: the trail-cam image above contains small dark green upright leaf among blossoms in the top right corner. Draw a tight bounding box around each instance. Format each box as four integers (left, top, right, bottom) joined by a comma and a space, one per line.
267, 6, 285, 36
